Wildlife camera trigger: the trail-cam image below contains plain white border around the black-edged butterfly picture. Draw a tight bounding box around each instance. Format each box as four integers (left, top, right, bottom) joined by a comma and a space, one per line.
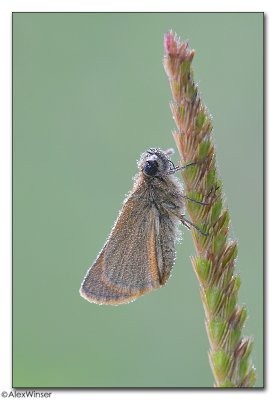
0, 0, 276, 400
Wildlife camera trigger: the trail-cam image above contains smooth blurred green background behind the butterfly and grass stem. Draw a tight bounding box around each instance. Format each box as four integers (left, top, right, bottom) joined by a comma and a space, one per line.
13, 13, 263, 387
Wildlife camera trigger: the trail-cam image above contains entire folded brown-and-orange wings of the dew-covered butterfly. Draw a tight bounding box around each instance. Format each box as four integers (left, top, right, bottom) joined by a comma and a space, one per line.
80, 186, 179, 304
